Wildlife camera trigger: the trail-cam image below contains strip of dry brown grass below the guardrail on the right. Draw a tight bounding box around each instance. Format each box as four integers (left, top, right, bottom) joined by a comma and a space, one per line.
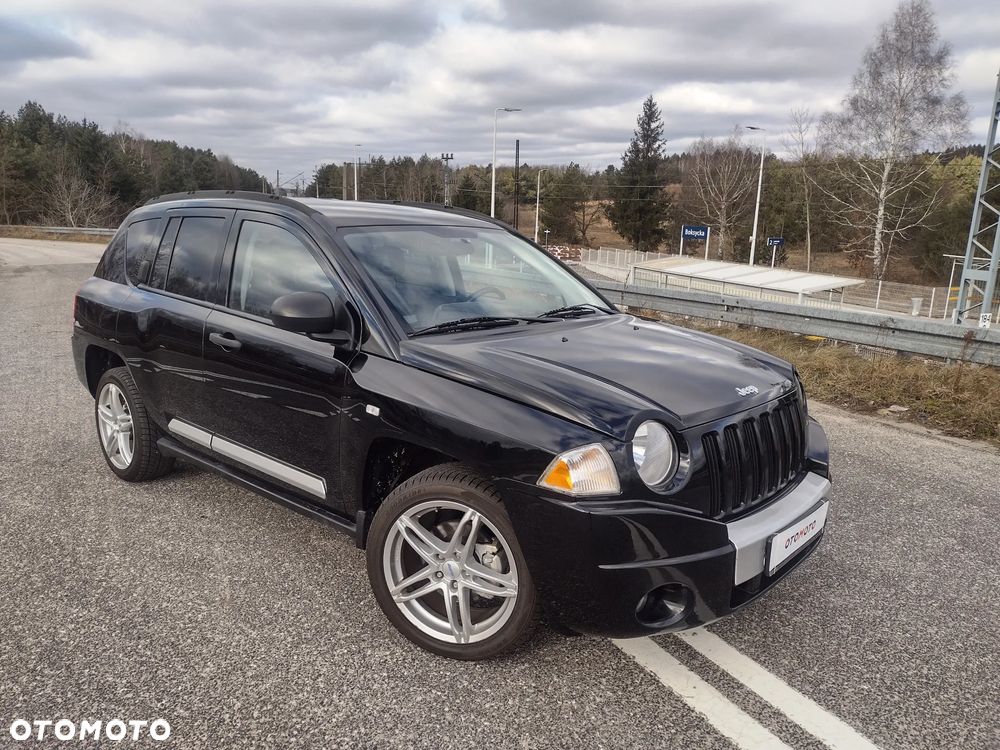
671, 320, 1000, 446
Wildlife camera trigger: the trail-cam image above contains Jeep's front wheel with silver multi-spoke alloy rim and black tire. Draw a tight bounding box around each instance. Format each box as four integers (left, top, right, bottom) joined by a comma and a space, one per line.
366, 464, 539, 661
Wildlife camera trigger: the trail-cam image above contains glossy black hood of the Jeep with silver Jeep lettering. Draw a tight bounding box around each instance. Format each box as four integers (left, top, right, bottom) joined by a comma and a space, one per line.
400, 315, 794, 439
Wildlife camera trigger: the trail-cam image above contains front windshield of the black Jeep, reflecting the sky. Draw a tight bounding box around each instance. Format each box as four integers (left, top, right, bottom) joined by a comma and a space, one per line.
342, 226, 608, 334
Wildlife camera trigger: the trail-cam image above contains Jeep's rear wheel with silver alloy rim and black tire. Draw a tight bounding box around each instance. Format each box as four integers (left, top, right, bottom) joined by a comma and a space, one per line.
94, 367, 174, 482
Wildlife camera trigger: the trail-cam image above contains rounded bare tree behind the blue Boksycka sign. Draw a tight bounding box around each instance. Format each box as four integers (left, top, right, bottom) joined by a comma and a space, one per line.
682, 131, 757, 259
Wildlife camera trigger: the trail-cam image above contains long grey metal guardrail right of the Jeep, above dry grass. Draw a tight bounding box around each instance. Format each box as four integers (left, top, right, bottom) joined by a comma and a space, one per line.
589, 279, 1000, 366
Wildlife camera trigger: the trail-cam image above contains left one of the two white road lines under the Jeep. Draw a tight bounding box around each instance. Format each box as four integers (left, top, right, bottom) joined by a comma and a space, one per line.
612, 638, 791, 750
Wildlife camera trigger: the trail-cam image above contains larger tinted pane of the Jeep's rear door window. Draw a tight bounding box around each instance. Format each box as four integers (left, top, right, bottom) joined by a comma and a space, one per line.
164, 216, 226, 300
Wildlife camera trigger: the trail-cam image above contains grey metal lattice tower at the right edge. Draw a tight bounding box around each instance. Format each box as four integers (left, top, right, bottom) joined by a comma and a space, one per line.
954, 70, 1000, 327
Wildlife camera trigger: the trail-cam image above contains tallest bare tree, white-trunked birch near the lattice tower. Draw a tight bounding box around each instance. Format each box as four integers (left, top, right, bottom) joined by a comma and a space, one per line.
814, 0, 968, 279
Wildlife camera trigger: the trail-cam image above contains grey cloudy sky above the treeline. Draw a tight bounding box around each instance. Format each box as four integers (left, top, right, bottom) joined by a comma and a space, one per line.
0, 0, 1000, 182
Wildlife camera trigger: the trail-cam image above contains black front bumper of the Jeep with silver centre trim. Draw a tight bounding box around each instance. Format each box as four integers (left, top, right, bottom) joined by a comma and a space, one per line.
501, 472, 830, 638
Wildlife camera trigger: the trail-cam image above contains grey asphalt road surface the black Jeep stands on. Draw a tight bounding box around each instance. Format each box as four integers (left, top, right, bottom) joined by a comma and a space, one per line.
0, 240, 1000, 749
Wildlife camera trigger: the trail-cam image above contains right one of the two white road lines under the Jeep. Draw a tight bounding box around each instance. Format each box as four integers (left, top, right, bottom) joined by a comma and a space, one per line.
676, 628, 878, 750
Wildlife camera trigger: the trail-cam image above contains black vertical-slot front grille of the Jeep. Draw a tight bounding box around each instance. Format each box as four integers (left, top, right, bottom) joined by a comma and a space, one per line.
701, 398, 806, 518
